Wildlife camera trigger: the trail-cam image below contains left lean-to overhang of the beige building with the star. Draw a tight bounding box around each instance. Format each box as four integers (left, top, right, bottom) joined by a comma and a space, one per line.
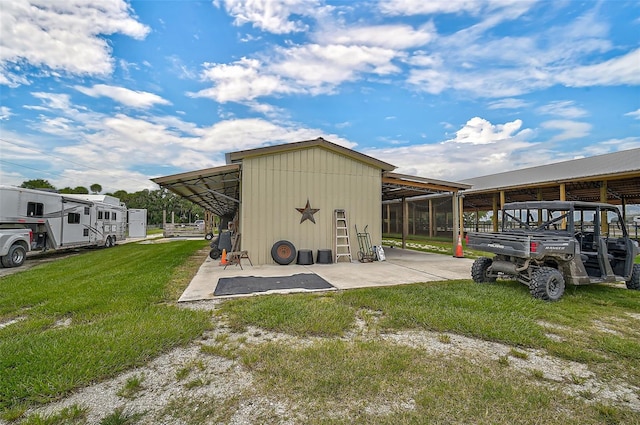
151, 164, 241, 218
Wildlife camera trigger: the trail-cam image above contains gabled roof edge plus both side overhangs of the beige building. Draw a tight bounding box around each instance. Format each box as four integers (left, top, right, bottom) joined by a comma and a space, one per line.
151, 138, 471, 218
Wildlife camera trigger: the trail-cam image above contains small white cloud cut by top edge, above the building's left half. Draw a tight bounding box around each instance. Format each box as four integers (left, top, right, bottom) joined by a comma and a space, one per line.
213, 0, 320, 34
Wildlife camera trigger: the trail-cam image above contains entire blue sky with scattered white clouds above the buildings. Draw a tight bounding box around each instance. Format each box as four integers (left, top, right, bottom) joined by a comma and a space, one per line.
0, 0, 640, 191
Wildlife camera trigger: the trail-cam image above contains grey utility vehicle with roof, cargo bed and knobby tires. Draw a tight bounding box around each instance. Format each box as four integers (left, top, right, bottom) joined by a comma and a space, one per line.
467, 201, 640, 301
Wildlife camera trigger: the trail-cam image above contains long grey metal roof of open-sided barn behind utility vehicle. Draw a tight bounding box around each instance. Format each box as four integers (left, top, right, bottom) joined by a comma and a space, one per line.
462, 149, 640, 209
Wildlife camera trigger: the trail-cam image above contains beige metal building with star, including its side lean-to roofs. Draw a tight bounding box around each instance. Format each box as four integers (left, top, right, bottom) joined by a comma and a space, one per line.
152, 138, 470, 264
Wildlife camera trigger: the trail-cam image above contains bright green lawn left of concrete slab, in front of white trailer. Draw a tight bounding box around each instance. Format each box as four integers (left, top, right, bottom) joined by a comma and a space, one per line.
0, 241, 209, 412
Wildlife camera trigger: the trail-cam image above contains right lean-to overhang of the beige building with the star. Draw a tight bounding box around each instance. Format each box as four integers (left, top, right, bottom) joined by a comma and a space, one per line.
382, 172, 471, 201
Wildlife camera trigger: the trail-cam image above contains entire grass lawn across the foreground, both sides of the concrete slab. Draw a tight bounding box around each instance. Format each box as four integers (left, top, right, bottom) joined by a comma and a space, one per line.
0, 237, 640, 425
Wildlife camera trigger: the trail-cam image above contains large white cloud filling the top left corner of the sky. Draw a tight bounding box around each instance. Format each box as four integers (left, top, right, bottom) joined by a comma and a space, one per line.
0, 0, 149, 86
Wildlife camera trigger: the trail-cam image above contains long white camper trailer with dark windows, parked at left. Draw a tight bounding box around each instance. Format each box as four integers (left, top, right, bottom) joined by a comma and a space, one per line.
0, 186, 127, 249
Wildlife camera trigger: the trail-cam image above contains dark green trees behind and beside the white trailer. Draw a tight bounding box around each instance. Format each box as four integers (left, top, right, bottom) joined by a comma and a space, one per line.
20, 179, 204, 225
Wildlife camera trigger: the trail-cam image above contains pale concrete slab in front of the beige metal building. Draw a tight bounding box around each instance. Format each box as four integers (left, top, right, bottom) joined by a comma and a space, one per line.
178, 248, 473, 302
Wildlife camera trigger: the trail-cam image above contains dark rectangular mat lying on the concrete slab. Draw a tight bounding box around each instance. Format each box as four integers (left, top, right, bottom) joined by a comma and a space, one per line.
213, 273, 333, 296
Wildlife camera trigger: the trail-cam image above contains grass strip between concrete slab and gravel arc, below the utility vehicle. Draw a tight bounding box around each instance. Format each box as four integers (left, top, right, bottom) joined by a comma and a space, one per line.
220, 281, 640, 386
